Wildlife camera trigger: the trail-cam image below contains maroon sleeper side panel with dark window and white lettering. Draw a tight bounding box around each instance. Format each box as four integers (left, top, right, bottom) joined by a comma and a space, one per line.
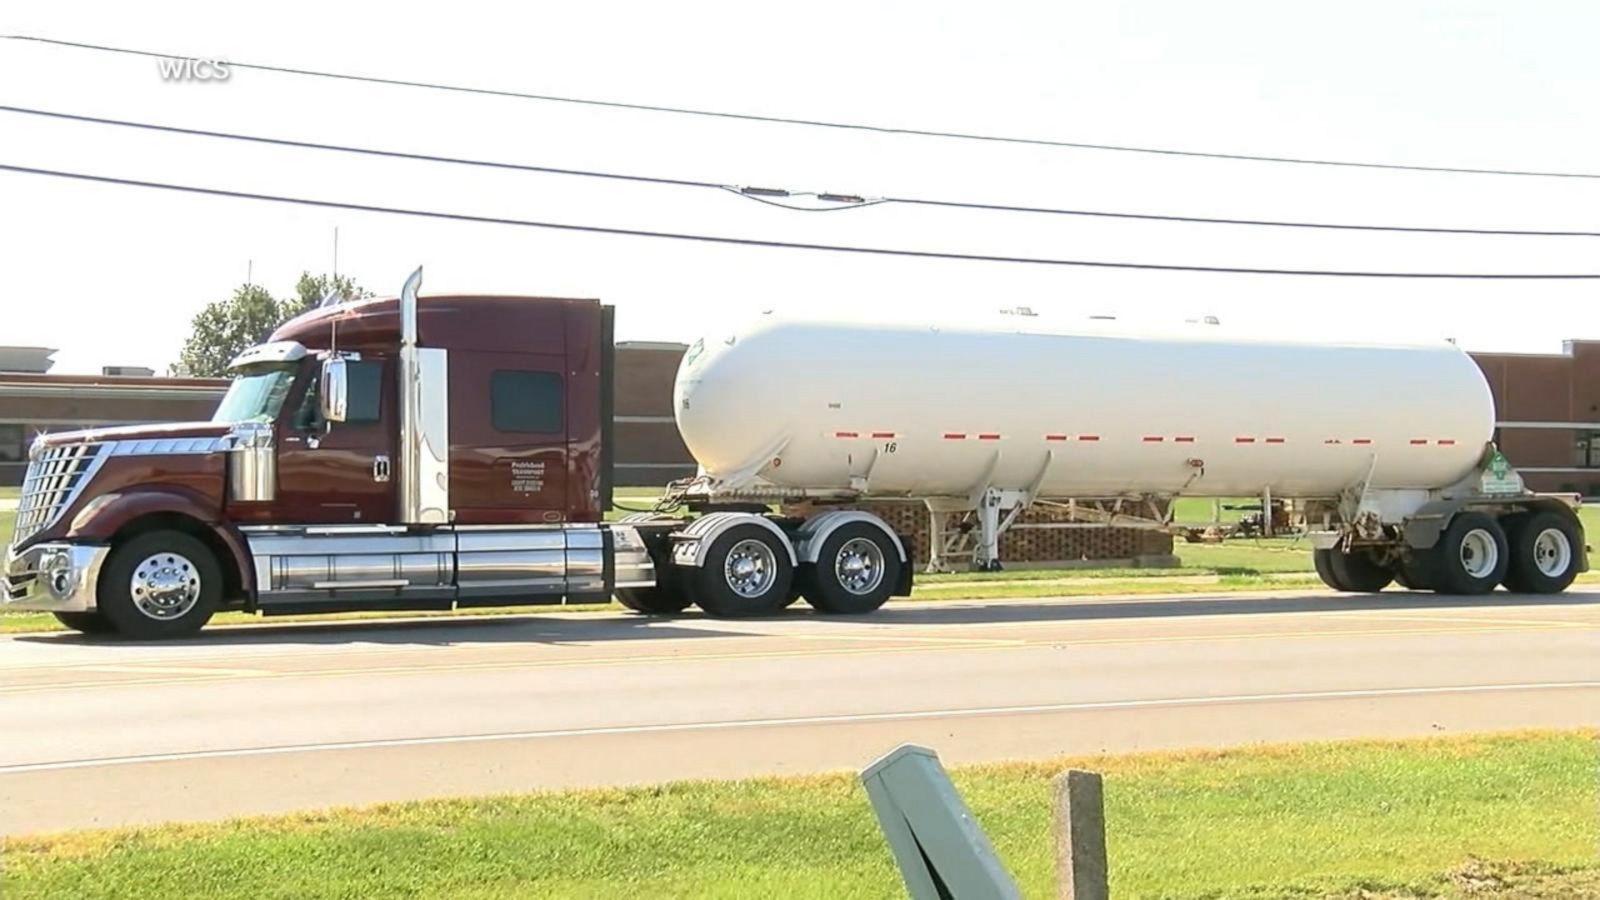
450, 351, 570, 524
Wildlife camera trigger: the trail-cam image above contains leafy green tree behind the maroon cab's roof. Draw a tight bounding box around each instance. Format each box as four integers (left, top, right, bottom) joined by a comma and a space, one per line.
170, 272, 373, 378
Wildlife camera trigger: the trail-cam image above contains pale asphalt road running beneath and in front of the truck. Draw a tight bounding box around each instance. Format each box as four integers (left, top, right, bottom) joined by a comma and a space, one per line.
0, 591, 1600, 834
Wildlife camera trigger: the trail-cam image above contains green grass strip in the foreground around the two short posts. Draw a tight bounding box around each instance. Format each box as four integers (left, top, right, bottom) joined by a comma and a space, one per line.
0, 732, 1600, 900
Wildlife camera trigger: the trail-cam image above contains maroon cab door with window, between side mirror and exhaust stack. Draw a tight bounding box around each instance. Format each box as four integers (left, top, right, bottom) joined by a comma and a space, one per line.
278, 357, 398, 524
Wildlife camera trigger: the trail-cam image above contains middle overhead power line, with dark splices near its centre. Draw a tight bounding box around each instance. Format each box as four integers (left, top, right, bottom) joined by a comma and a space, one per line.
0, 104, 1600, 237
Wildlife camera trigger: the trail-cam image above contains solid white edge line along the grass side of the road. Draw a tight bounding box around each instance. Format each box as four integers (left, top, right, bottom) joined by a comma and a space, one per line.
0, 681, 1600, 775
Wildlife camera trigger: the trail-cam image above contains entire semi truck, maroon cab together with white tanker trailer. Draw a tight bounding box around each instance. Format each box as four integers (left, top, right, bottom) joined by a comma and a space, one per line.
0, 269, 1587, 639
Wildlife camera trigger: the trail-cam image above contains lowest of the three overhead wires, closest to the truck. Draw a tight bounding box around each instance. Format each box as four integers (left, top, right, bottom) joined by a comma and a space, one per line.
0, 163, 1600, 280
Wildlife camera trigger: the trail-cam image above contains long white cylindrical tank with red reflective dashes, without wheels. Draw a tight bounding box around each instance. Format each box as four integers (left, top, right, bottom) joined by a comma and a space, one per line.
674, 315, 1494, 498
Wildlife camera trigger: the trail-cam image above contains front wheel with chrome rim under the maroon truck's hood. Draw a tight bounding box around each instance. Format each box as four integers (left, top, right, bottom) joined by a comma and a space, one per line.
96, 532, 222, 641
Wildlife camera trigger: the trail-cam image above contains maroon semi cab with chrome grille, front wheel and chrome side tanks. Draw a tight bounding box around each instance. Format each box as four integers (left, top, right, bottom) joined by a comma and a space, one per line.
0, 274, 654, 637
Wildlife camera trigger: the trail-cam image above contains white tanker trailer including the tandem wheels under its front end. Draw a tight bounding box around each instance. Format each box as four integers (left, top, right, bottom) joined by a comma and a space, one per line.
617, 315, 1587, 615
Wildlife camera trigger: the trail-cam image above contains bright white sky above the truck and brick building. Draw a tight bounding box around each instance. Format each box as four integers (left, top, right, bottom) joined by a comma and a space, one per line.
0, 0, 1600, 372
